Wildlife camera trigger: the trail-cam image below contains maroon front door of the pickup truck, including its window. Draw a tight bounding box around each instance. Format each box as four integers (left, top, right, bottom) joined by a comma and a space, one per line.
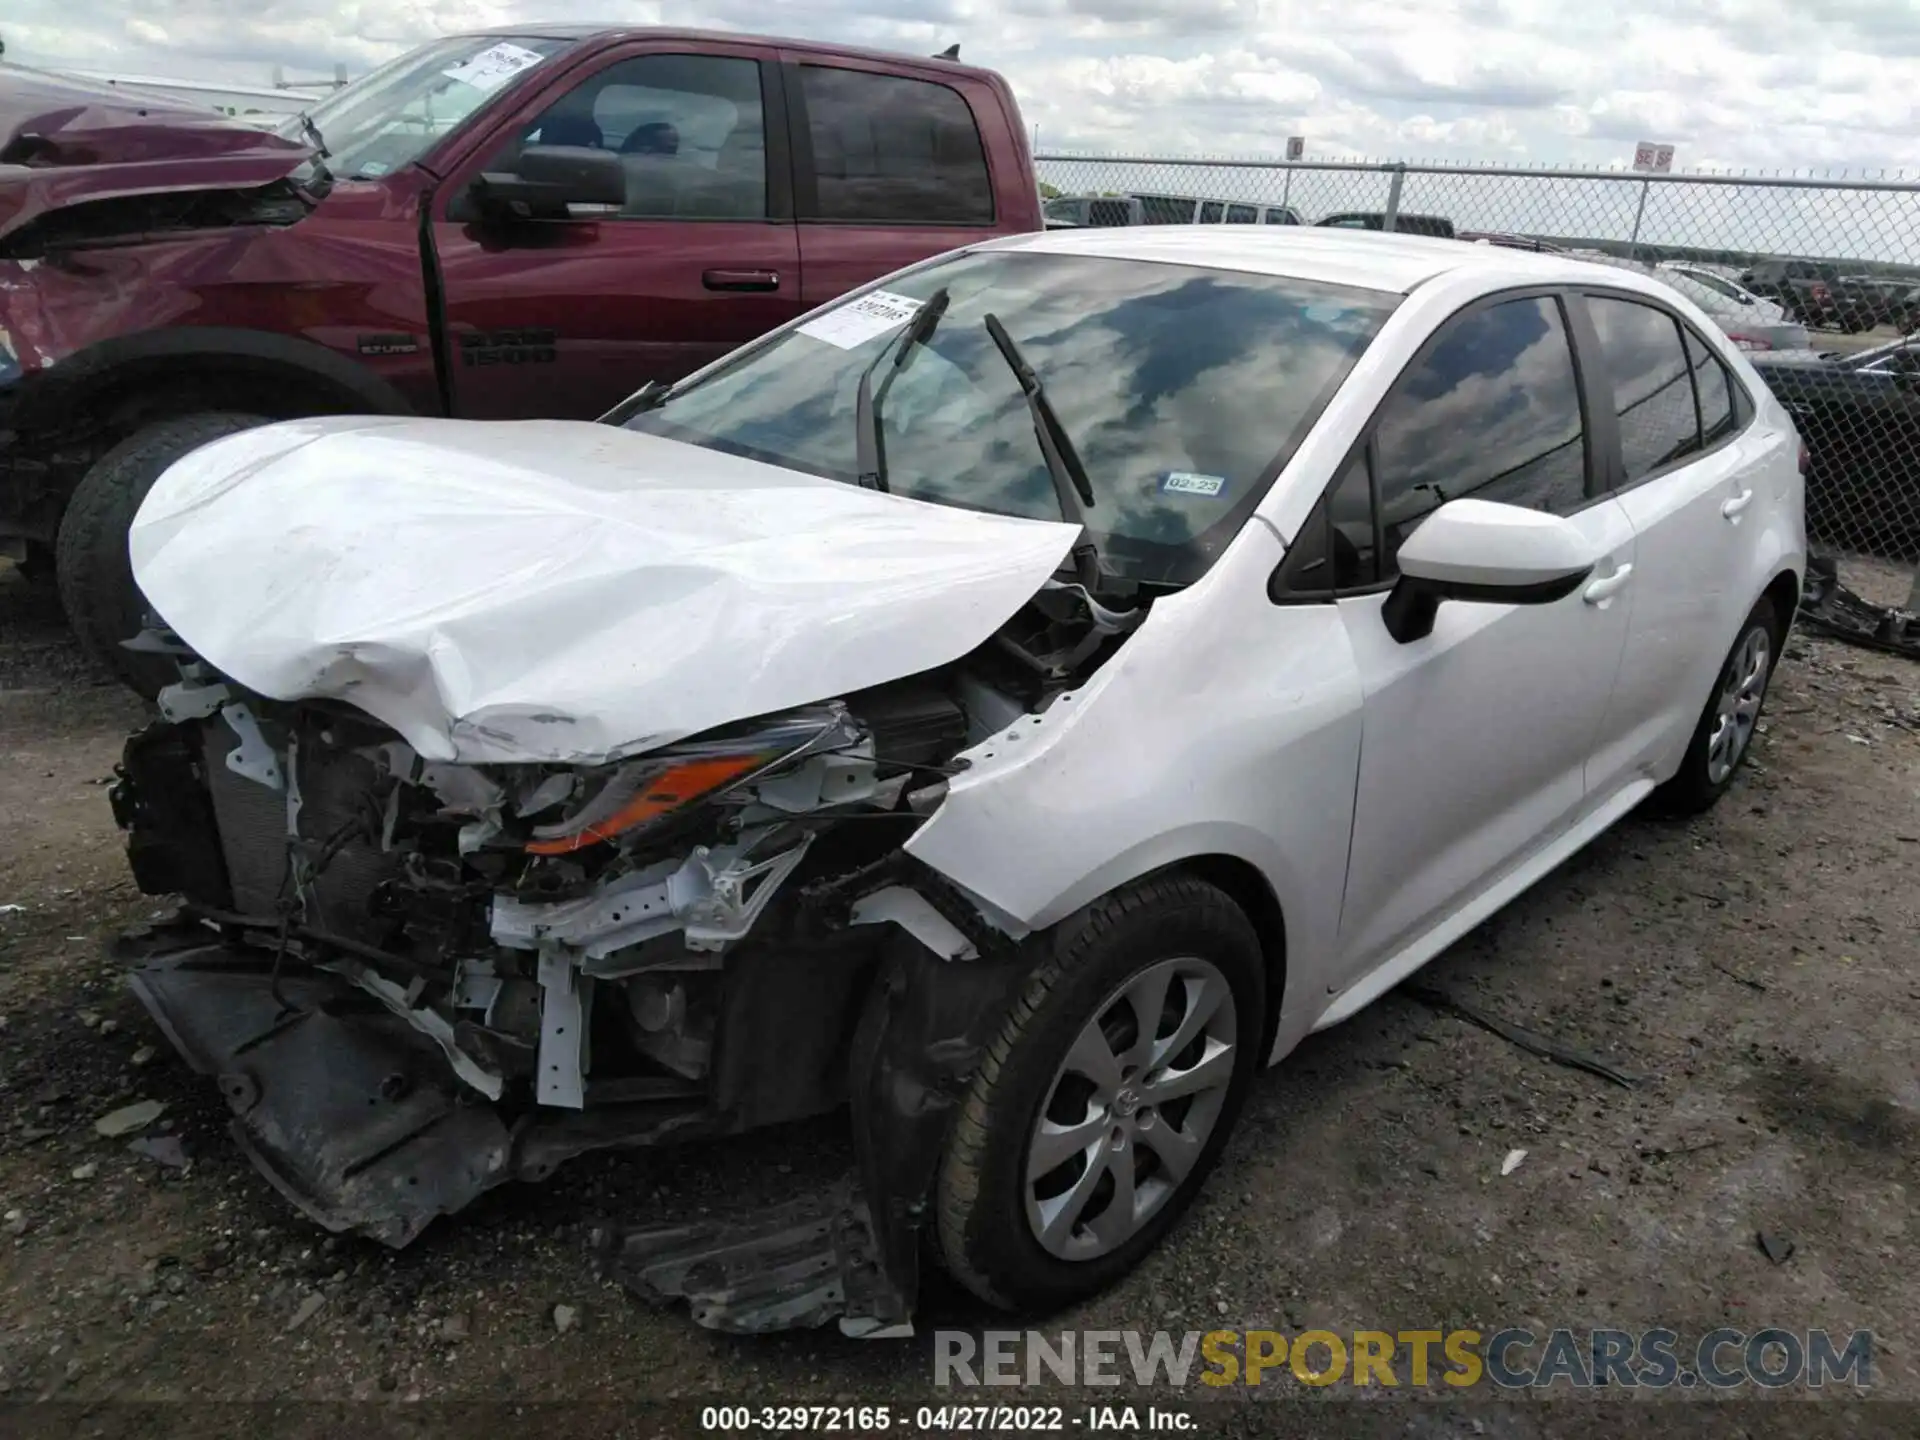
434, 40, 803, 419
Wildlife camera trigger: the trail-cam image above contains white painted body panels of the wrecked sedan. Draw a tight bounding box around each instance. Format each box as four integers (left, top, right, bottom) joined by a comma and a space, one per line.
134, 227, 1805, 1060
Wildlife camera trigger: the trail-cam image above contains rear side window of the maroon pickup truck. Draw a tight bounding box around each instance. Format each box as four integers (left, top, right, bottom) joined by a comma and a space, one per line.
801, 65, 993, 225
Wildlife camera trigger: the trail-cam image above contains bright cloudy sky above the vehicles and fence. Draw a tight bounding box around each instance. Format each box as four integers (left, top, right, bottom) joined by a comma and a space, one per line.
0, 0, 1920, 169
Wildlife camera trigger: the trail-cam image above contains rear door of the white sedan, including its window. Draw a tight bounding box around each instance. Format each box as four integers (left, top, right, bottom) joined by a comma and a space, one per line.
1584, 292, 1776, 785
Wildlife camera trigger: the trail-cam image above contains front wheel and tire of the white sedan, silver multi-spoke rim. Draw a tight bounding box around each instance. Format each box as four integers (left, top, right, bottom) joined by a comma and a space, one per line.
935, 872, 1265, 1311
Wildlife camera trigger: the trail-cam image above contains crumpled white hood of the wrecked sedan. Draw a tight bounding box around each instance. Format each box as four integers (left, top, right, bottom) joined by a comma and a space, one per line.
131, 419, 1079, 764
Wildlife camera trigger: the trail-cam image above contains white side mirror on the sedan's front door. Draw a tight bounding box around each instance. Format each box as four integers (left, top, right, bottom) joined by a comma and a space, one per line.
1380, 499, 1594, 645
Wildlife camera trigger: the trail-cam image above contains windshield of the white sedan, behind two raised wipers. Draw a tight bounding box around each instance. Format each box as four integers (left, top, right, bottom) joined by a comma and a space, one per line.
626, 252, 1400, 586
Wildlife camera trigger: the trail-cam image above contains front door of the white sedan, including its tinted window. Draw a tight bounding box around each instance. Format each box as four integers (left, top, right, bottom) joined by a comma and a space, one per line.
1336, 296, 1634, 989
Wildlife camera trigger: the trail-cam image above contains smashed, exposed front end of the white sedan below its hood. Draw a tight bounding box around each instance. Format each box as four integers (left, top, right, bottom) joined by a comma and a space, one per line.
113, 584, 1140, 1334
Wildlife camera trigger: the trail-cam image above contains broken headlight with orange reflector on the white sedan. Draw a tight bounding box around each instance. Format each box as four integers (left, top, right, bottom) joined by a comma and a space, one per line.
526, 705, 860, 854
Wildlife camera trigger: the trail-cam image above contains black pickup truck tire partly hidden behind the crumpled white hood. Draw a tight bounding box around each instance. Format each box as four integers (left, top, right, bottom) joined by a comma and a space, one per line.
54, 411, 269, 699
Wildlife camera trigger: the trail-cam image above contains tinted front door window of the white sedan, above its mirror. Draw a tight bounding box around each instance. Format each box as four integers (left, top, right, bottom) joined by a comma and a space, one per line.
1375, 298, 1586, 564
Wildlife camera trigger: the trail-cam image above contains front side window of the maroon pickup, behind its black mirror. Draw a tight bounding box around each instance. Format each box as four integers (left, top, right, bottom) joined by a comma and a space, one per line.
503, 56, 766, 221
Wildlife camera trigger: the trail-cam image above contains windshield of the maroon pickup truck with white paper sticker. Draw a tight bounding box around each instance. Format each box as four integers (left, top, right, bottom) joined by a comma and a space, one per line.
276, 35, 568, 180
